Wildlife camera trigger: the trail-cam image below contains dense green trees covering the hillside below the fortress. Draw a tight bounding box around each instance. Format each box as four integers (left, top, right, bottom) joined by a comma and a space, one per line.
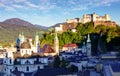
41, 22, 120, 54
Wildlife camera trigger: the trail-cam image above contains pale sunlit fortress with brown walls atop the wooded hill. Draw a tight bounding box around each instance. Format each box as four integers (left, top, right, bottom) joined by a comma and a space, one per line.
55, 13, 116, 32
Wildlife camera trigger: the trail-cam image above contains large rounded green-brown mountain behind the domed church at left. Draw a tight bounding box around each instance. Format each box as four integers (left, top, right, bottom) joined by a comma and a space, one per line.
0, 18, 46, 44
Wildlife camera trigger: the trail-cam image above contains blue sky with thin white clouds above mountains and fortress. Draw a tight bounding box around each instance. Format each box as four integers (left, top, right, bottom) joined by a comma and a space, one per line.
0, 0, 120, 26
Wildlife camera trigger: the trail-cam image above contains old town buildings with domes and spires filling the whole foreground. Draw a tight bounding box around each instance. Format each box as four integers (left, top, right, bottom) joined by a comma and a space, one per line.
0, 30, 120, 76
